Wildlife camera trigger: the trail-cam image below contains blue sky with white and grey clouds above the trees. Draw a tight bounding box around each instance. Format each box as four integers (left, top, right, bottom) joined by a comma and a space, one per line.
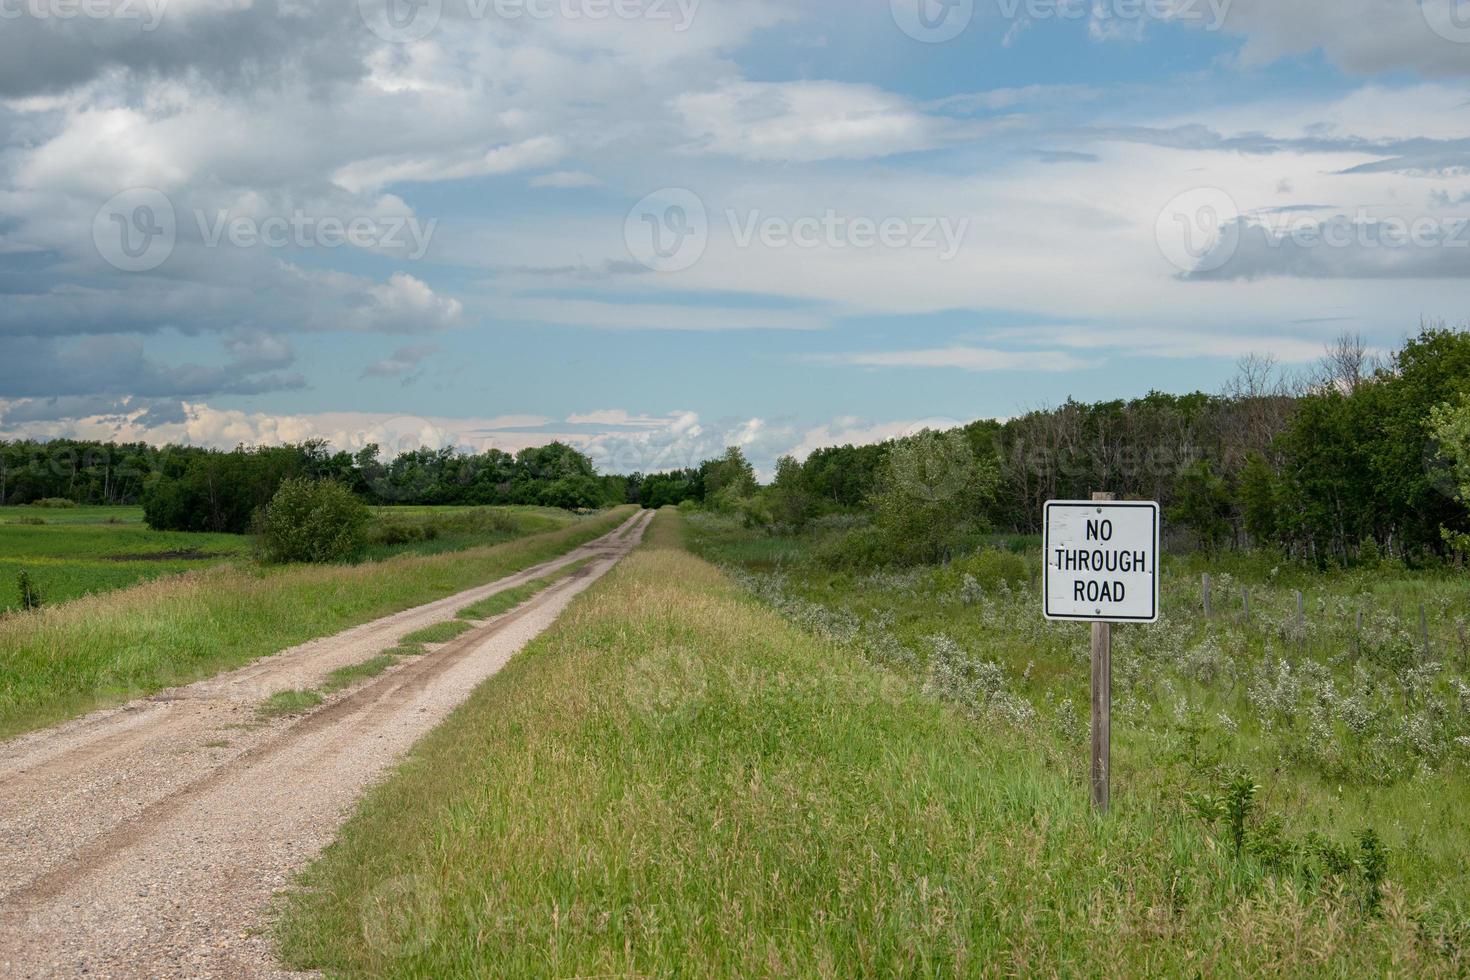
0, 0, 1470, 473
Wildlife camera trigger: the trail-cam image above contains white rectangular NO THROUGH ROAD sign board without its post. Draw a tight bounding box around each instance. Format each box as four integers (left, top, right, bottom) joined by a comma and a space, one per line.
1042, 500, 1158, 623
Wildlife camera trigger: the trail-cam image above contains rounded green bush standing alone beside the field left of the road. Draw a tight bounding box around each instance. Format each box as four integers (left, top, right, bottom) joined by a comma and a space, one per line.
257, 478, 369, 563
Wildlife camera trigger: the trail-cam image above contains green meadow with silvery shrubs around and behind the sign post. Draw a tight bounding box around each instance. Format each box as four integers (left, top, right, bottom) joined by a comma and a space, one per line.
692, 516, 1470, 942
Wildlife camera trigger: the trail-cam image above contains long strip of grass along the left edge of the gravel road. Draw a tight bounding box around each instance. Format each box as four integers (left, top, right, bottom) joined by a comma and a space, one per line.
0, 507, 632, 738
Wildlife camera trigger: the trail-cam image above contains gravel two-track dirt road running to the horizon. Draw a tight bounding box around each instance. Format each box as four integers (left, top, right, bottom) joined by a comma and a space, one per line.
0, 511, 651, 979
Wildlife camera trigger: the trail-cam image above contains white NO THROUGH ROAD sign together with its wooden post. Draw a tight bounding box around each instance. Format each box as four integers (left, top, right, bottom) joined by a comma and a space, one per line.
1042, 494, 1160, 813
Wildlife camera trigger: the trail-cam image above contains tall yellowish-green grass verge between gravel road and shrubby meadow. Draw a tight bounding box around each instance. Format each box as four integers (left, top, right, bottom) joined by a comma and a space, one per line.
278, 511, 1467, 977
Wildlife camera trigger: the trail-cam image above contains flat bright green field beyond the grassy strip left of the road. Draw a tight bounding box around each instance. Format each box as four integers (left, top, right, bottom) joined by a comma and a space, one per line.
0, 507, 576, 613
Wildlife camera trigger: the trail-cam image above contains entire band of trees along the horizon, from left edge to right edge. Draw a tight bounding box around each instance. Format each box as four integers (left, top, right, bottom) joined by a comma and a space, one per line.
11, 326, 1470, 564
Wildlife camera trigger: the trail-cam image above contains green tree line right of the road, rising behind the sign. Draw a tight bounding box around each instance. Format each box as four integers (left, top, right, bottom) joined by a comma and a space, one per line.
682, 326, 1470, 564
